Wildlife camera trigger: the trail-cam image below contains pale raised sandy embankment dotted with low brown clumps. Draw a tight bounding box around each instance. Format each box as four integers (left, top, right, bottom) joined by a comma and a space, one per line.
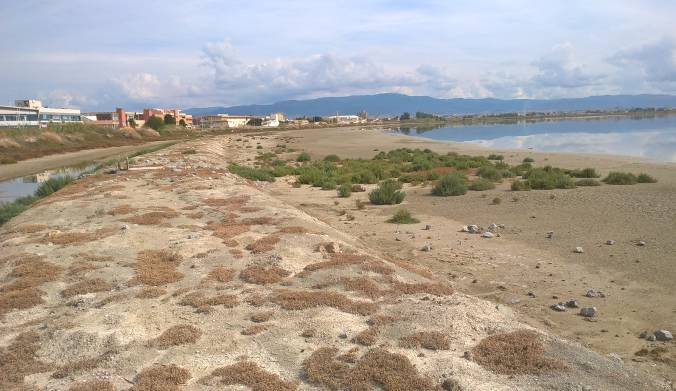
0, 135, 671, 391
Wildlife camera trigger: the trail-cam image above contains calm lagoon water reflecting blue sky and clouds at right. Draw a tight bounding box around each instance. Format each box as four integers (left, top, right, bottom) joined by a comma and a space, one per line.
391, 115, 676, 162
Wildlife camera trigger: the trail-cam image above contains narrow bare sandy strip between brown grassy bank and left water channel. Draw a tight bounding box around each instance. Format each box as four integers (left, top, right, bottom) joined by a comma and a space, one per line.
0, 141, 167, 181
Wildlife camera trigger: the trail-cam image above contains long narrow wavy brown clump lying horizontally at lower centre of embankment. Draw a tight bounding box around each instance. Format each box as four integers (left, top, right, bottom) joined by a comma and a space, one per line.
271, 290, 378, 315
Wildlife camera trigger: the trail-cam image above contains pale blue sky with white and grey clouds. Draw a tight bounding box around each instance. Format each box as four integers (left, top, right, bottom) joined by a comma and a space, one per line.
0, 0, 676, 110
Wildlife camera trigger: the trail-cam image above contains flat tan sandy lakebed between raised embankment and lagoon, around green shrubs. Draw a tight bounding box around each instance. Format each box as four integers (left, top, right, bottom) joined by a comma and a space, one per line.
271, 129, 676, 380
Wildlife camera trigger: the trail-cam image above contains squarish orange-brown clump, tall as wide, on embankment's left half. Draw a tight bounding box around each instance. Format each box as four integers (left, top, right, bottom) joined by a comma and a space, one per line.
136, 250, 183, 286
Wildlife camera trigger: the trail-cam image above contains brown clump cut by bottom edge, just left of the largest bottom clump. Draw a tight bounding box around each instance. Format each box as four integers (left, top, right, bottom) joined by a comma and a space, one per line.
211, 361, 298, 391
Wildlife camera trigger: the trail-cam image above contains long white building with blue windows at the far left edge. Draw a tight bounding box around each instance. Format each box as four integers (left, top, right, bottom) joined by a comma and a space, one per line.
0, 99, 82, 127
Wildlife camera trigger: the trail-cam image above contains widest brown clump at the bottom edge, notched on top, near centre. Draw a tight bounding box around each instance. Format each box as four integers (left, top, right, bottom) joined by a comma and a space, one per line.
303, 348, 436, 391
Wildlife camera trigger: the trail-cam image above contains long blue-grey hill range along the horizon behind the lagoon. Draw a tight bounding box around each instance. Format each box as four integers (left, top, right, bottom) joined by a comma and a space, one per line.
185, 93, 676, 118
